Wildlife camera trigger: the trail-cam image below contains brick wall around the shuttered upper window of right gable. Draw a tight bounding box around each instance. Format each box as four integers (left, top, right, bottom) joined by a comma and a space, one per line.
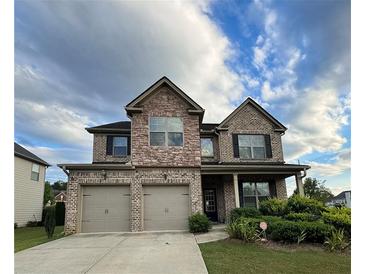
219, 104, 283, 162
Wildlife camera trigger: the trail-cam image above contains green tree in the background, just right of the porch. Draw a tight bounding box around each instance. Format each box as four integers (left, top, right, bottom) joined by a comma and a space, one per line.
294, 177, 333, 203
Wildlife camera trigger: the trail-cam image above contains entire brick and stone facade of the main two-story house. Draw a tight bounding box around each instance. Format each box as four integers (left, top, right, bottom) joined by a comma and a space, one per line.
65, 78, 300, 234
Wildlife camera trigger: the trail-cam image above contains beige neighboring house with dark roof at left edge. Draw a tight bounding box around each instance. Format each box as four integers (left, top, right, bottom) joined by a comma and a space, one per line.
14, 142, 50, 226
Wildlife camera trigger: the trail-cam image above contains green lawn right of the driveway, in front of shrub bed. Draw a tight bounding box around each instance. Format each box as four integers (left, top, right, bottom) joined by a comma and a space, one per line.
199, 240, 351, 274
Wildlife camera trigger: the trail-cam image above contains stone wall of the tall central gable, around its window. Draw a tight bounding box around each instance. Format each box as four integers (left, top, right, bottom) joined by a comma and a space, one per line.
131, 86, 201, 167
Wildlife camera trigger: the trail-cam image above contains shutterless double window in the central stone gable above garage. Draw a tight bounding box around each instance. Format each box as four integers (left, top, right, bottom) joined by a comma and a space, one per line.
150, 117, 184, 146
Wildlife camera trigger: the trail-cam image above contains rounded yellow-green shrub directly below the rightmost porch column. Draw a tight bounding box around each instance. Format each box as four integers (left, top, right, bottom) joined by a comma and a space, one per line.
285, 195, 325, 216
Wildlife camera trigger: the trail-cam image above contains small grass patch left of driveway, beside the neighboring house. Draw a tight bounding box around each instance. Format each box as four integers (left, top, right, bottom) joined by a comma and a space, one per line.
14, 226, 63, 252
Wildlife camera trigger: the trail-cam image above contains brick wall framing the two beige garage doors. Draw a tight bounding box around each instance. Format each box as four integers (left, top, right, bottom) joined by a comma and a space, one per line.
65, 168, 203, 234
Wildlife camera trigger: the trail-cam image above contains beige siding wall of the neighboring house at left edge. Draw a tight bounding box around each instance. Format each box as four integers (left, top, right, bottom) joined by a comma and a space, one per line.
14, 156, 46, 226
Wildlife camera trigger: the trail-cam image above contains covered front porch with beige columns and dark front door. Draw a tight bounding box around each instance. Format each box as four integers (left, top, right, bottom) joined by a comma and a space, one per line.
201, 164, 310, 223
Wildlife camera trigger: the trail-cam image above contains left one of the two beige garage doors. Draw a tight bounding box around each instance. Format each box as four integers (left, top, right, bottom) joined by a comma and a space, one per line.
81, 186, 130, 232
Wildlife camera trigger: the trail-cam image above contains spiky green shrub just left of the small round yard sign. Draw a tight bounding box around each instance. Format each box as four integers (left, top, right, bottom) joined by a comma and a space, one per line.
227, 217, 259, 242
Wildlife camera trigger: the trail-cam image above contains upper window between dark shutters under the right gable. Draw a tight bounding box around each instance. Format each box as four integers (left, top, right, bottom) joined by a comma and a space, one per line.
238, 135, 266, 159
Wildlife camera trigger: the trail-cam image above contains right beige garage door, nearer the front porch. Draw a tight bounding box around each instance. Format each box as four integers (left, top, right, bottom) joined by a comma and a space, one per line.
143, 185, 190, 231
